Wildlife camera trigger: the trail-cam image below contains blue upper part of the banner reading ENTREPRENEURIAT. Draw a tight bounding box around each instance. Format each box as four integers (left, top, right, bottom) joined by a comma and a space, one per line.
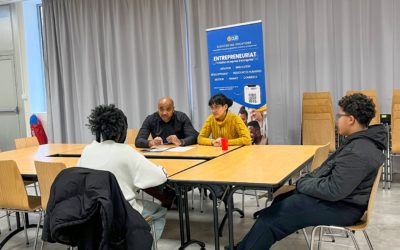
207, 21, 267, 108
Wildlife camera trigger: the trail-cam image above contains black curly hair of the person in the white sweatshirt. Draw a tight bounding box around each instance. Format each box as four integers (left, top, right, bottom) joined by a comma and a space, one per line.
86, 104, 128, 143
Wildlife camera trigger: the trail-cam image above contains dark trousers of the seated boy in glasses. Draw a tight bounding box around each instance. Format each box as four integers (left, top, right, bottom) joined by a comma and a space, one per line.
237, 190, 366, 250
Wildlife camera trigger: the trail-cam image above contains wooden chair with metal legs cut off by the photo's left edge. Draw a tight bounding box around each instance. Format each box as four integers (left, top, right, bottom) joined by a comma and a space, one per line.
0, 160, 42, 248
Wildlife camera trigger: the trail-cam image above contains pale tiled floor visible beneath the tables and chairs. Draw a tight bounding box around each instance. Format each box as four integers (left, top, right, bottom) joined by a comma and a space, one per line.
0, 183, 400, 250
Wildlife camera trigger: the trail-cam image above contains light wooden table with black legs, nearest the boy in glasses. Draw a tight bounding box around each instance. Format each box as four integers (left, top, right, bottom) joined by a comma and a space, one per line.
169, 145, 320, 249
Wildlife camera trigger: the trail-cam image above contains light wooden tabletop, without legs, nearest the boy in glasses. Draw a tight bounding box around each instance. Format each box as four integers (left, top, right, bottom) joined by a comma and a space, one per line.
170, 145, 320, 187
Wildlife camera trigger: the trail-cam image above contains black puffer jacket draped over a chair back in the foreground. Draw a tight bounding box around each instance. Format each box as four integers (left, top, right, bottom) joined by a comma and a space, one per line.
42, 167, 153, 250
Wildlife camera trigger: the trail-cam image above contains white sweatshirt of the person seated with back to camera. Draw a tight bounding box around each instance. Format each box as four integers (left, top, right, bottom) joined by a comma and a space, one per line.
78, 140, 167, 213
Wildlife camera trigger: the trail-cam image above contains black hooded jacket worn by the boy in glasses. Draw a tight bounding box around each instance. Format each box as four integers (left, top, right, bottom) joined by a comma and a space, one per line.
296, 125, 387, 206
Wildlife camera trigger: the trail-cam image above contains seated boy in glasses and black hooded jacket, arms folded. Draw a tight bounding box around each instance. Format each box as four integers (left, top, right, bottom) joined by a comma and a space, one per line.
235, 93, 387, 250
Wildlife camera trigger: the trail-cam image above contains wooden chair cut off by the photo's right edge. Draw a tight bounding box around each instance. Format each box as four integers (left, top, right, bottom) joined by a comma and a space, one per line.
385, 89, 400, 188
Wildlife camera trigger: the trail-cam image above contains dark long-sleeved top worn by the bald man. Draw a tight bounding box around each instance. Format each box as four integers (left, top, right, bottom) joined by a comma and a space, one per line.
135, 111, 199, 148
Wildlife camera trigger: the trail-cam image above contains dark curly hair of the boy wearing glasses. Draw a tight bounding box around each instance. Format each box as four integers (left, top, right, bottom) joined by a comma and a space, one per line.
338, 93, 375, 128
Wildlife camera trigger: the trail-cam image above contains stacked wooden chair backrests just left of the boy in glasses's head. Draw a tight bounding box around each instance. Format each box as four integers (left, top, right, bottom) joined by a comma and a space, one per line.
302, 92, 335, 152
